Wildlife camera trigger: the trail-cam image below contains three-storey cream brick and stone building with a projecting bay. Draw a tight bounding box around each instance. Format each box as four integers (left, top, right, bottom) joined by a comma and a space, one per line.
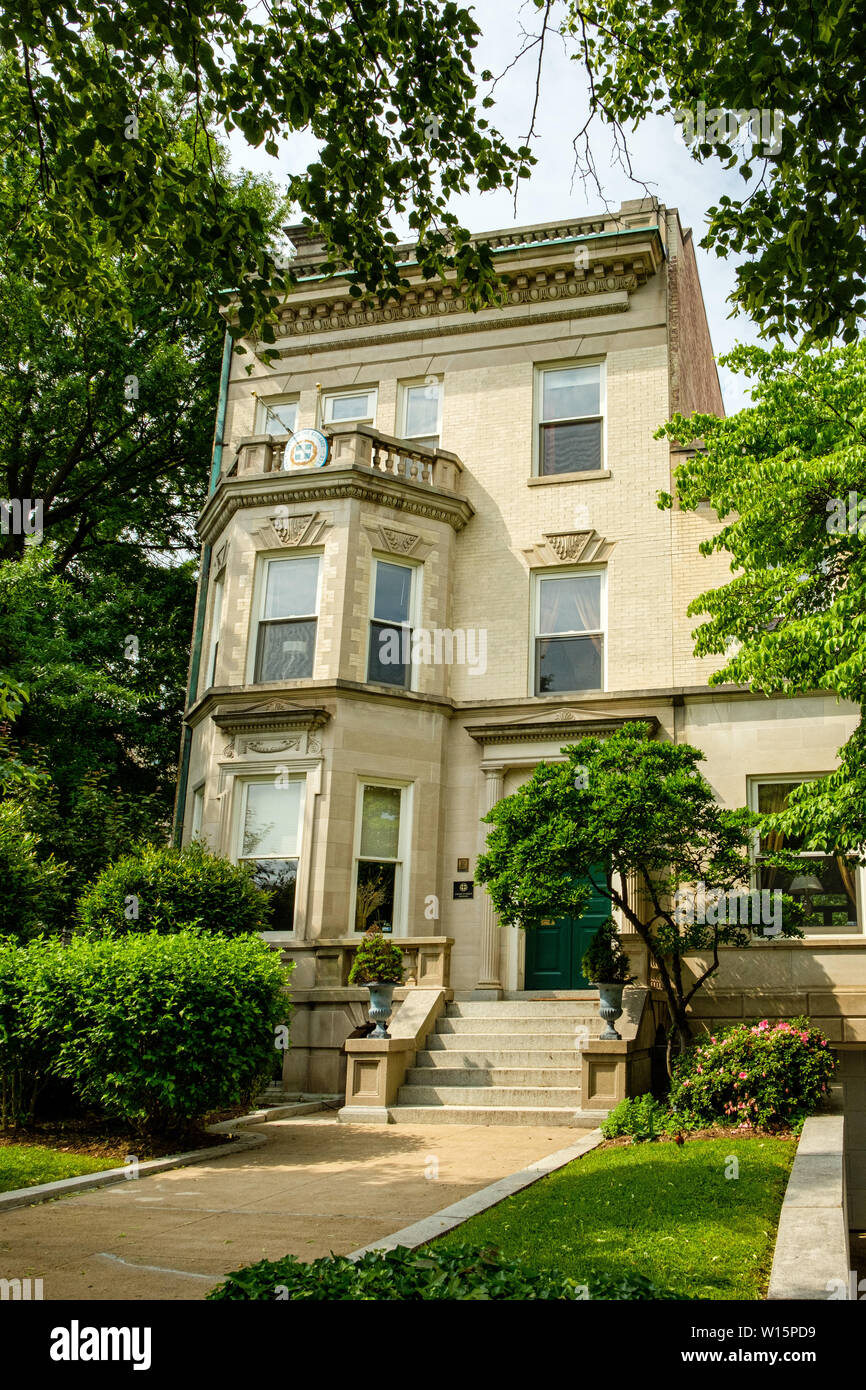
179, 200, 866, 1184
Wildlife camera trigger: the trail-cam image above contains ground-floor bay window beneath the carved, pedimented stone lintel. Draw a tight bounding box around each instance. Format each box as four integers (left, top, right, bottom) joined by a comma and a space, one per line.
238, 773, 306, 931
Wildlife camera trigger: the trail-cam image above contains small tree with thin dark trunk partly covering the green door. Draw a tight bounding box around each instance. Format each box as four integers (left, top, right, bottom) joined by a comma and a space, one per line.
475, 723, 801, 1051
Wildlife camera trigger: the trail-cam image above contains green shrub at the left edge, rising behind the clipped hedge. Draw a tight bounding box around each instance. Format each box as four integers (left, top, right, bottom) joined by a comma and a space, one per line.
0, 801, 65, 941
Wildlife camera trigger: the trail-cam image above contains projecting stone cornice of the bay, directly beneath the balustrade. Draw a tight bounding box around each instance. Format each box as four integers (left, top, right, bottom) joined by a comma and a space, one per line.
197, 464, 475, 545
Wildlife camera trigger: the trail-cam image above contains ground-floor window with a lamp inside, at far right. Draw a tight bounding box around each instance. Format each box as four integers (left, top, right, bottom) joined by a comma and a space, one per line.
749, 777, 858, 931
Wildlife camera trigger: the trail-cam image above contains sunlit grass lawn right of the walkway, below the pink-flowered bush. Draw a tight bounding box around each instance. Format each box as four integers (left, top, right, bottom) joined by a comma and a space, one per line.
434, 1138, 796, 1298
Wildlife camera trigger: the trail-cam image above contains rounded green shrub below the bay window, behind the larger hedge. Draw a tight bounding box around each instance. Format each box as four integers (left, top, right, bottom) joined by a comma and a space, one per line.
78, 841, 271, 937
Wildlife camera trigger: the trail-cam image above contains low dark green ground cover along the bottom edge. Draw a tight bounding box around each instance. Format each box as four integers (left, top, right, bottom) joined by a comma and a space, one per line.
207, 1245, 670, 1302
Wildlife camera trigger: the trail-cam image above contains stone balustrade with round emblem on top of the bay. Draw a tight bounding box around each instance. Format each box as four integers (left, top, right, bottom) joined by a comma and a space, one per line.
231, 424, 463, 492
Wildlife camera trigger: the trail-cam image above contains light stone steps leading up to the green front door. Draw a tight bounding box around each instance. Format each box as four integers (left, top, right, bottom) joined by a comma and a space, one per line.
389, 994, 602, 1126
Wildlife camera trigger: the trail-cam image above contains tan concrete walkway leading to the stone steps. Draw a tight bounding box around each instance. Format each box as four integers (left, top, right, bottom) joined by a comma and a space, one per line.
0, 1113, 588, 1300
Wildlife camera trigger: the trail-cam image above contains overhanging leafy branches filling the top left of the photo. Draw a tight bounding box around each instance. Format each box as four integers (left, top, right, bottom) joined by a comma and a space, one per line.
0, 0, 528, 343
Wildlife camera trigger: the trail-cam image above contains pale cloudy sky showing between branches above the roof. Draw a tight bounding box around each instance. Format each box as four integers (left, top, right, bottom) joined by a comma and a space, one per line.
229, 0, 759, 414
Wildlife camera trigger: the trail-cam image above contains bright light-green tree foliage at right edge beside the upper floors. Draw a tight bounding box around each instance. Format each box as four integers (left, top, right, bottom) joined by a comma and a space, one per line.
659, 343, 866, 852
